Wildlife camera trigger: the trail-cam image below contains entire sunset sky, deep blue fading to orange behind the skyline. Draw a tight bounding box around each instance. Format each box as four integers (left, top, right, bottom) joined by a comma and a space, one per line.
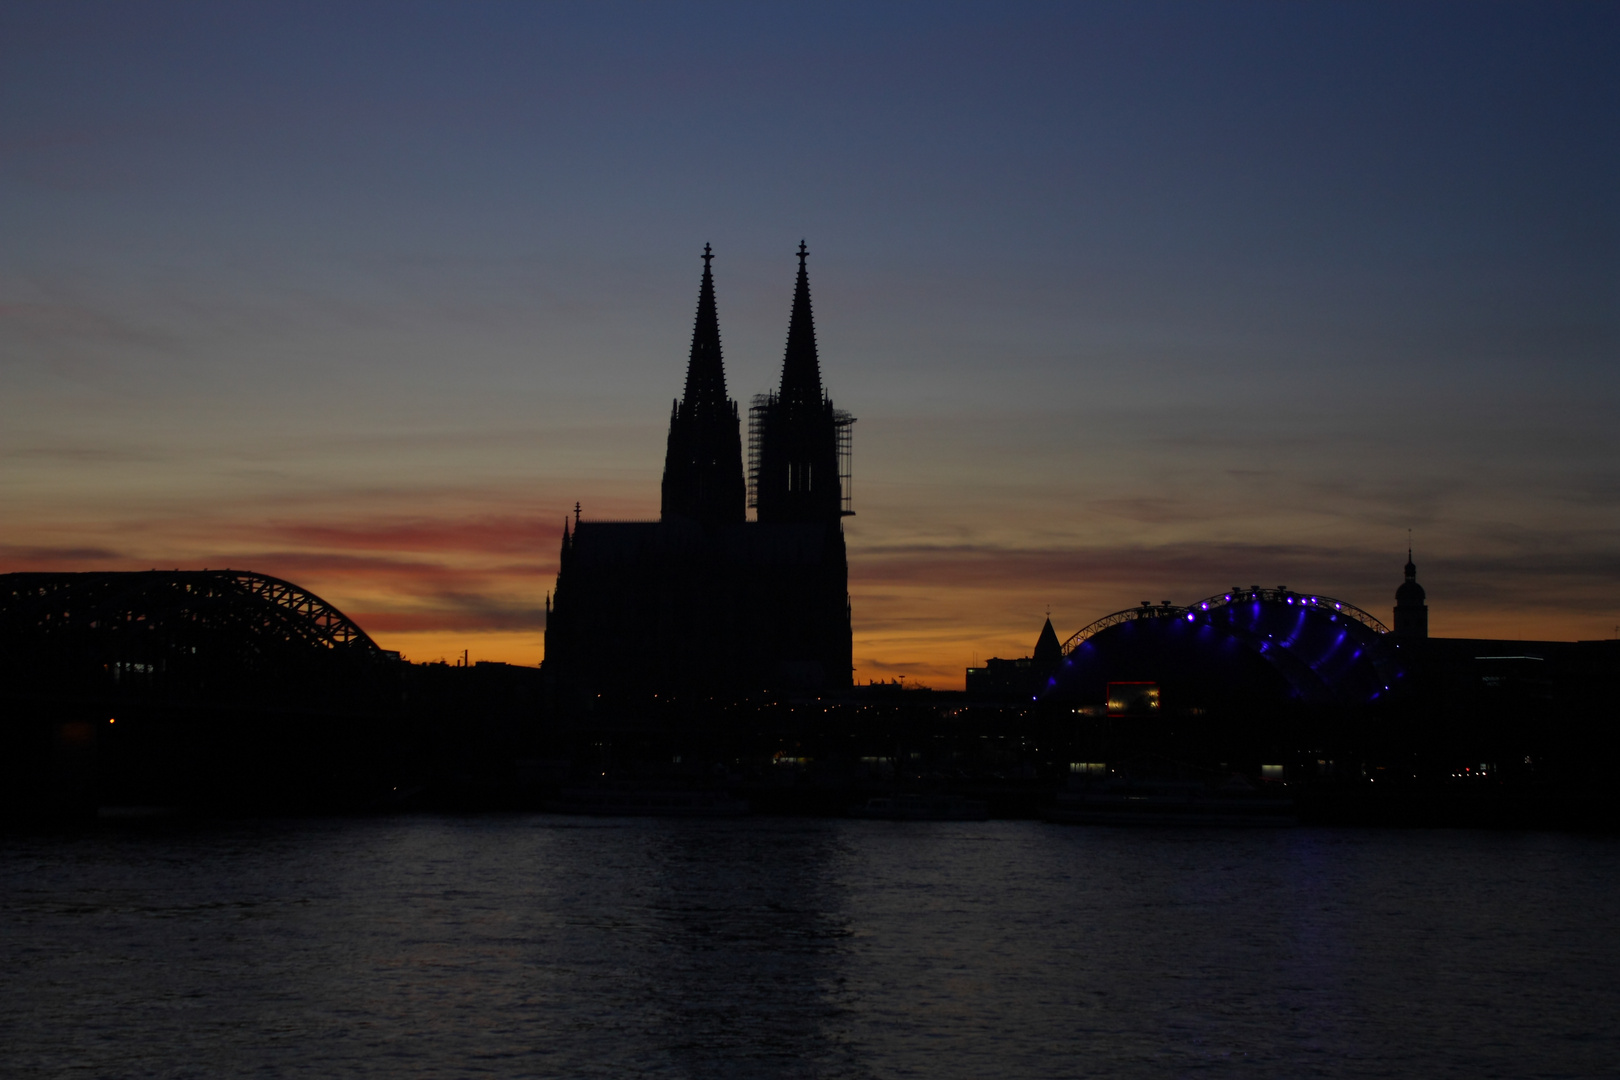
0, 2, 1620, 687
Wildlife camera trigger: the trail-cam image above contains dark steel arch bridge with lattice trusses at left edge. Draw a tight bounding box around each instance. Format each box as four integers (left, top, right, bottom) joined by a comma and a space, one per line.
0, 570, 407, 811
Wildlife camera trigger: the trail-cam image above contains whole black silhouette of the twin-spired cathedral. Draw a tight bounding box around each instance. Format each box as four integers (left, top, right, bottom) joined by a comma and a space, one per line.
544, 243, 854, 711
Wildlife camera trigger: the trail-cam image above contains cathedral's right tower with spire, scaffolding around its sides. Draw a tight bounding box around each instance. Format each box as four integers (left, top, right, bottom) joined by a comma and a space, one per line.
748, 241, 854, 523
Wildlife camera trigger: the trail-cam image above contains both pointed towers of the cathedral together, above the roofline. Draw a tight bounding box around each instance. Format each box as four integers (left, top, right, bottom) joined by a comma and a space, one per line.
663, 243, 842, 528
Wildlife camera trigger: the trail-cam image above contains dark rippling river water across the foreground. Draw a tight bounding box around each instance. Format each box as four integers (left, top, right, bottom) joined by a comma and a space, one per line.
0, 814, 1620, 1078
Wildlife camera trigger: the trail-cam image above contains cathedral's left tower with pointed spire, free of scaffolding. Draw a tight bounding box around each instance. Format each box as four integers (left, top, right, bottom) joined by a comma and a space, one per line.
661, 244, 747, 529
